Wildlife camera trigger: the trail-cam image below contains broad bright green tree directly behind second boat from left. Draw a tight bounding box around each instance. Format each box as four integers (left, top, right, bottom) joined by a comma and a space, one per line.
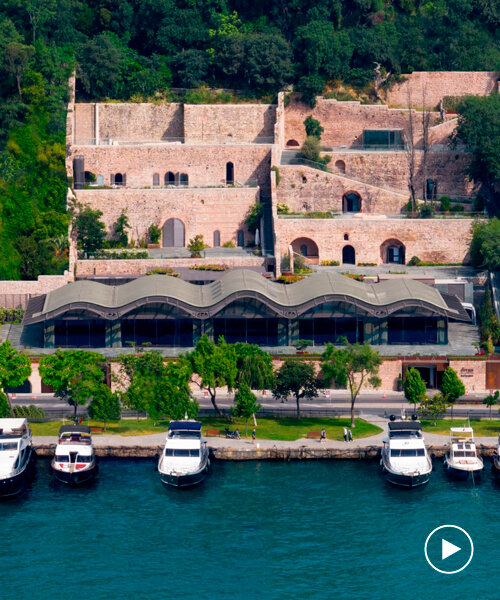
39, 350, 105, 419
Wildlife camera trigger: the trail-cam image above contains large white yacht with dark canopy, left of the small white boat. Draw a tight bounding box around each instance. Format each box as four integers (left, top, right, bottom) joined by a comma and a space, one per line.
380, 421, 432, 488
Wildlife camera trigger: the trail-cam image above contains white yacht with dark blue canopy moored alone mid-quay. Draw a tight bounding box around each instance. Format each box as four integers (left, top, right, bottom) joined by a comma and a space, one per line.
158, 419, 210, 487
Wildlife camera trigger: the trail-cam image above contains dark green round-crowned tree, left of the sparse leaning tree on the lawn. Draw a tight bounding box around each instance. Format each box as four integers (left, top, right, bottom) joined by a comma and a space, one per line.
273, 360, 321, 419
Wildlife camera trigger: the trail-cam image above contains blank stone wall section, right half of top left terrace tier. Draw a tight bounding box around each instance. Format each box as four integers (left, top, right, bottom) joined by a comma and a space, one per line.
184, 104, 276, 143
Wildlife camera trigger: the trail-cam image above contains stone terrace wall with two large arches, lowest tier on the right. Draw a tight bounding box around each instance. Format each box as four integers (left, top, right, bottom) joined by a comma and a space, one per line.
275, 217, 473, 264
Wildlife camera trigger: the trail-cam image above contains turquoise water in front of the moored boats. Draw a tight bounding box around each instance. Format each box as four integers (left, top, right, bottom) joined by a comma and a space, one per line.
0, 460, 500, 600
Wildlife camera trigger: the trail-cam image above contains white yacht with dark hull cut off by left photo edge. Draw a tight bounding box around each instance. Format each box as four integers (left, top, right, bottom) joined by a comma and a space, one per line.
0, 419, 35, 496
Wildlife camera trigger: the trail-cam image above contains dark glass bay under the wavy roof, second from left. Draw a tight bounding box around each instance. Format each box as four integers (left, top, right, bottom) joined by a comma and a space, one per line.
121, 319, 193, 348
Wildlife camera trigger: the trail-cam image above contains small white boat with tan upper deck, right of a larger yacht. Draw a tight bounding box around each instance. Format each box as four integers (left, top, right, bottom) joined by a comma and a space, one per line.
444, 427, 484, 479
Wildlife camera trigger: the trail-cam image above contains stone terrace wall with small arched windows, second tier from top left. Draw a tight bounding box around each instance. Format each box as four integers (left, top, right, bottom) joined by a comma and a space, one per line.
67, 144, 271, 188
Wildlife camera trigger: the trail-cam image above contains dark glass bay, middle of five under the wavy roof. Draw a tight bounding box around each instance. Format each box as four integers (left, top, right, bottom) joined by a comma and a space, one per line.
213, 319, 279, 346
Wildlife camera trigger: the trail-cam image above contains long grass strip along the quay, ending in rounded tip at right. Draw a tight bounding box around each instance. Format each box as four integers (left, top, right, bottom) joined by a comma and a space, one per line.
31, 417, 382, 441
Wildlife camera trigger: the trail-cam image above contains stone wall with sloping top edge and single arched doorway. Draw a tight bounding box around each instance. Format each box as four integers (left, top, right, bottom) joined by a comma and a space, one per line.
276, 165, 408, 215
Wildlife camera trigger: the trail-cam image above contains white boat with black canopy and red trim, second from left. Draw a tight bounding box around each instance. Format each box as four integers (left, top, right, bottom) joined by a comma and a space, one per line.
51, 425, 98, 484
